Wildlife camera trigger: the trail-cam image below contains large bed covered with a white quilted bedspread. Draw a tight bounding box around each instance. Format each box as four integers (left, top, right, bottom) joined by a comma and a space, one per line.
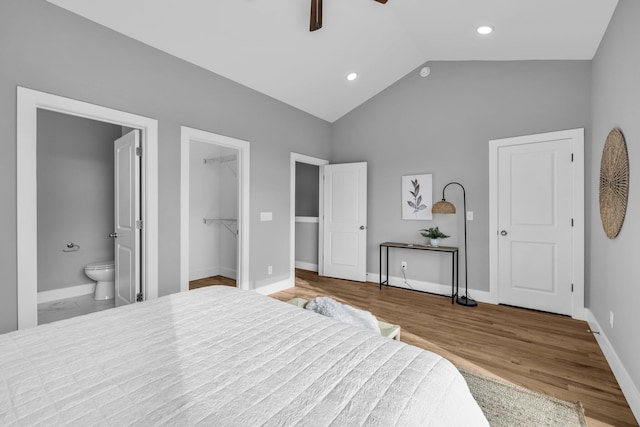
0, 286, 488, 427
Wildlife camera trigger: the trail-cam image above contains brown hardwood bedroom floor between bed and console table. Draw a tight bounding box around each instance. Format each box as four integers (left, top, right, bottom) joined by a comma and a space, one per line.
271, 270, 638, 426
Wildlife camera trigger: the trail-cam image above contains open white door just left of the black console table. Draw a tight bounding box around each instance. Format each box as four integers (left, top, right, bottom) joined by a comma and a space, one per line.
322, 162, 367, 282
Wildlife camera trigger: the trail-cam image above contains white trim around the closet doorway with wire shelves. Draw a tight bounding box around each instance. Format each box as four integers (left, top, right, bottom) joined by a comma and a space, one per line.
180, 126, 250, 292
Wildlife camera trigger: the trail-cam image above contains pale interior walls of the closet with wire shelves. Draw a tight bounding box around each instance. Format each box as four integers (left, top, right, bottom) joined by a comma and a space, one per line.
189, 141, 238, 280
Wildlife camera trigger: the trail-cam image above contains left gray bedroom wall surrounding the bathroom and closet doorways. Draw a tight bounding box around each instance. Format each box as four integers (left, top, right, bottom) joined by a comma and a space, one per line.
0, 0, 331, 332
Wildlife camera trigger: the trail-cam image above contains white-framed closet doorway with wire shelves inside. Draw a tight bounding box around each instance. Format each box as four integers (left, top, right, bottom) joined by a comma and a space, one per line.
180, 127, 249, 291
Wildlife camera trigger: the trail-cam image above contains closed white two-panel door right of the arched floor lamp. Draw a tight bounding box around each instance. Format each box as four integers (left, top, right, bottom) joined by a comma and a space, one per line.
497, 135, 573, 315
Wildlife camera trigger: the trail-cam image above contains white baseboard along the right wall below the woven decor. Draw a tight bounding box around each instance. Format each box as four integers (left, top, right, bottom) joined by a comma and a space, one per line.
585, 308, 640, 421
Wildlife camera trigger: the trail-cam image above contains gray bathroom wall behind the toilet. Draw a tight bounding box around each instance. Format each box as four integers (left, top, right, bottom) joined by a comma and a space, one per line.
37, 110, 122, 292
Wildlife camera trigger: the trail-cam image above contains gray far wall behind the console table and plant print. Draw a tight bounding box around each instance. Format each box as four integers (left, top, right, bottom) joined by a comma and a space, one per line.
331, 61, 591, 296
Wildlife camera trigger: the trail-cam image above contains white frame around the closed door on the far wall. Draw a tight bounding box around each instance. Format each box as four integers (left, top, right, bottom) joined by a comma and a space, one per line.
489, 128, 586, 320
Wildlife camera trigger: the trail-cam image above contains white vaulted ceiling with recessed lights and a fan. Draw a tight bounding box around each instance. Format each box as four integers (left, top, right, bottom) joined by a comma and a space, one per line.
48, 0, 617, 122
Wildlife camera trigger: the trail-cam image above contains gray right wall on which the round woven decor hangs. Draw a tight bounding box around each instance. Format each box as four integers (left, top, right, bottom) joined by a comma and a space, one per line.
586, 0, 640, 394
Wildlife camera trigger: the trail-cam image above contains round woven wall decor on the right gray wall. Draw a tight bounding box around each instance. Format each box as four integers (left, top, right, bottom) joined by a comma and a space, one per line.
600, 129, 629, 239
